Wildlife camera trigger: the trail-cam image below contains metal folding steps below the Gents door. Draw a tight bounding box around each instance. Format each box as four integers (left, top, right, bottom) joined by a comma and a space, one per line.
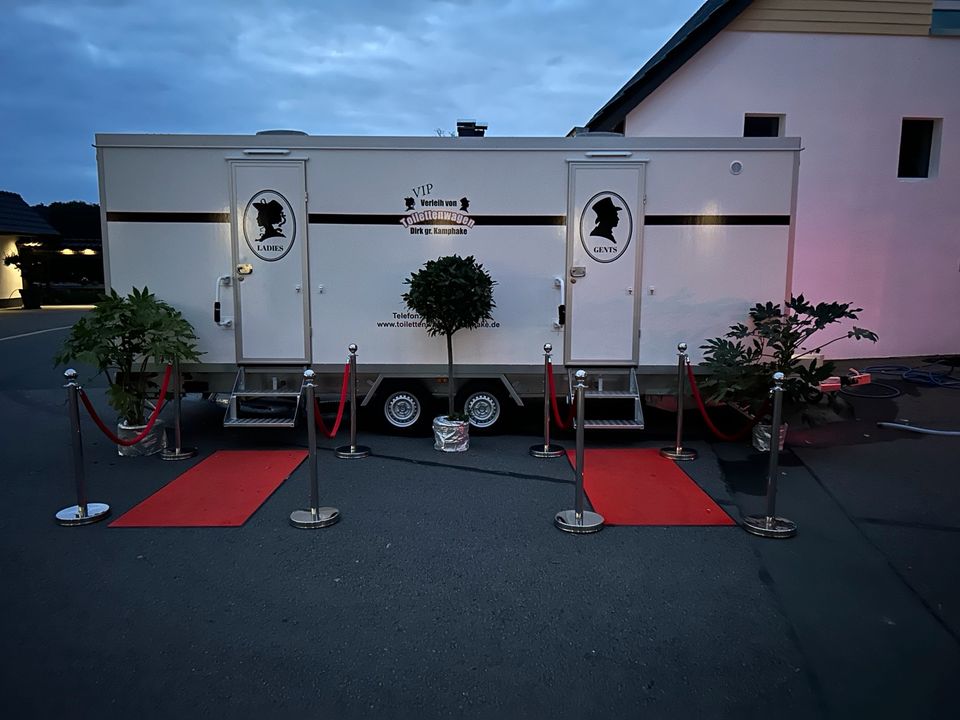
567, 367, 644, 430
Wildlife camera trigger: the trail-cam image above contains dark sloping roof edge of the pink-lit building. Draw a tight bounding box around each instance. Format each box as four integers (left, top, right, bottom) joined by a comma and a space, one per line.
586, 0, 751, 132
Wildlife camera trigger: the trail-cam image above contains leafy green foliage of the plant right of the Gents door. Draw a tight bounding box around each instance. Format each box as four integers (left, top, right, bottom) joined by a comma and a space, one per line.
700, 295, 877, 415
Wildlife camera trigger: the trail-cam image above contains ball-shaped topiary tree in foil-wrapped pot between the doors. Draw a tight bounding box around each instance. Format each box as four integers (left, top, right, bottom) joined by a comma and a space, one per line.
402, 255, 496, 452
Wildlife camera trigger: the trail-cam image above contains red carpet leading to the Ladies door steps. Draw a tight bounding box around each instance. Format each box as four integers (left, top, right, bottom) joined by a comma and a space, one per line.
110, 450, 307, 527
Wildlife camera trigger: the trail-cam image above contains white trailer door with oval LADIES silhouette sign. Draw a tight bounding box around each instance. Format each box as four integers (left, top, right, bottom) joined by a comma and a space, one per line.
230, 160, 310, 363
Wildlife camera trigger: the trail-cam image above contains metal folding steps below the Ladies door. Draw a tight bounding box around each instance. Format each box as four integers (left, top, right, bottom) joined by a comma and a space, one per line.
223, 365, 303, 427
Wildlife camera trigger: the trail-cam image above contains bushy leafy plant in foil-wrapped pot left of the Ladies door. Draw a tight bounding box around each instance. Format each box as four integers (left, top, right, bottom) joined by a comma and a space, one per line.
54, 287, 200, 455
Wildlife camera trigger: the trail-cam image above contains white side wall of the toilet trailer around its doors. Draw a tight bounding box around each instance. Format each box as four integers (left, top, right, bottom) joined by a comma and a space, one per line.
98, 135, 798, 386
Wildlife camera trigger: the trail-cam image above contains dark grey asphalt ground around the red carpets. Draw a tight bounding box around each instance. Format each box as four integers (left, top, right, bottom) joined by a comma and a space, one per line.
0, 310, 960, 718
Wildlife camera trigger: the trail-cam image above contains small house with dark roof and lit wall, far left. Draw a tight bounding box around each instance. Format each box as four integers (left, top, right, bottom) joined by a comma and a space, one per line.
0, 190, 59, 307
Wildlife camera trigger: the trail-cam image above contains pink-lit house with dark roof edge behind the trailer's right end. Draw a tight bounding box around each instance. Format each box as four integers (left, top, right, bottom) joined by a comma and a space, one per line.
586, 0, 960, 358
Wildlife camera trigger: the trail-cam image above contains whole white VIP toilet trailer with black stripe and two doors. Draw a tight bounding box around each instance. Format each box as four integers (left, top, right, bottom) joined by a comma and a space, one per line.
96, 133, 800, 429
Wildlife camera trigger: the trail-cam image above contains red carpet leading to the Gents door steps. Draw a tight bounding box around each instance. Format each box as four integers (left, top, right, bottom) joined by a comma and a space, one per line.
567, 449, 735, 525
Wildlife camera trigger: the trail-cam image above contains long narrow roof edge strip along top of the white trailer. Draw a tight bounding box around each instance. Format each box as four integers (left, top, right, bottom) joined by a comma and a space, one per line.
96, 133, 800, 152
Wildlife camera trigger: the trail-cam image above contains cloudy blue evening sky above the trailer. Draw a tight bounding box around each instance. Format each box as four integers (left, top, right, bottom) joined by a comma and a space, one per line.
0, 0, 698, 203
